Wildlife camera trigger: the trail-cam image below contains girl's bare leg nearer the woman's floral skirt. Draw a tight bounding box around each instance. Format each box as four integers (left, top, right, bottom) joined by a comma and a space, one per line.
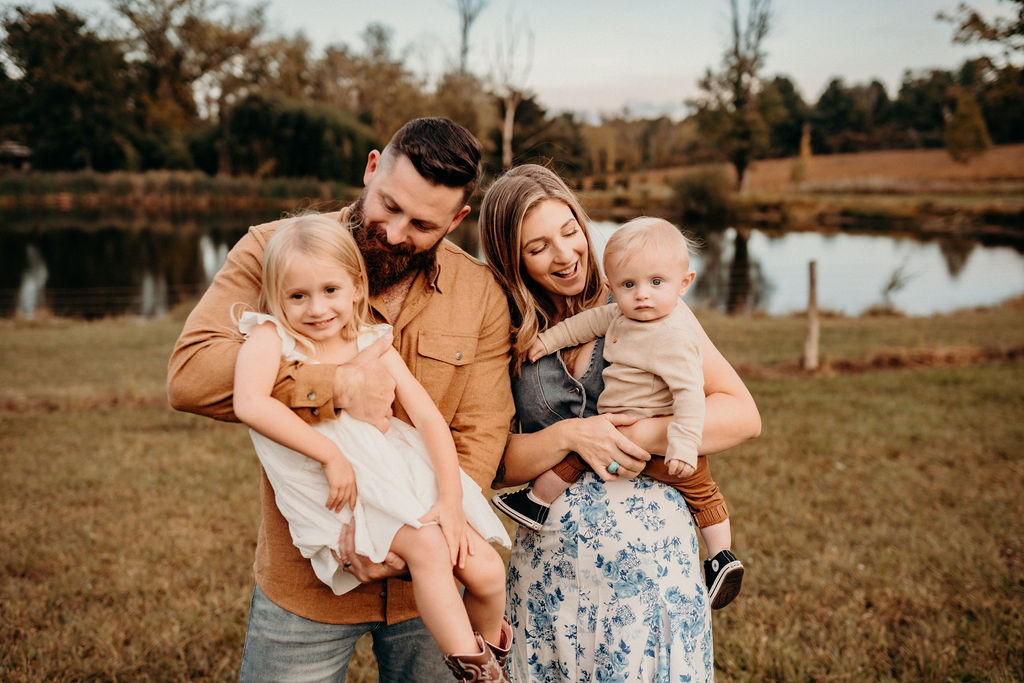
455, 527, 505, 643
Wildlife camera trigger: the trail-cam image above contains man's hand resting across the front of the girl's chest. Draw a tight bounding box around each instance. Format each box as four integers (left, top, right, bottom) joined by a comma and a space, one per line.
334, 334, 395, 432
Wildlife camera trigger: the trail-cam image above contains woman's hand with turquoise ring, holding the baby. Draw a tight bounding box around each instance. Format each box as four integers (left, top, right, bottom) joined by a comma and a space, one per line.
563, 414, 650, 481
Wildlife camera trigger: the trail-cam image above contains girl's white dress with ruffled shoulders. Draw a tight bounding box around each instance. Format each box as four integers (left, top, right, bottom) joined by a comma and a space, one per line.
239, 311, 512, 595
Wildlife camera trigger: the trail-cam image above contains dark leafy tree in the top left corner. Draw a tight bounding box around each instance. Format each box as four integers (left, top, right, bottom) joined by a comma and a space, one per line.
0, 7, 135, 170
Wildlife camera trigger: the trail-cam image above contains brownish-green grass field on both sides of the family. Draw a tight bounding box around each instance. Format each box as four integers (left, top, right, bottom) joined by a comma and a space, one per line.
0, 301, 1024, 681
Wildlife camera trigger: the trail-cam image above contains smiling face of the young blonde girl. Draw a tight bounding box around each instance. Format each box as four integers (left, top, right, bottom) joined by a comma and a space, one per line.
281, 254, 359, 342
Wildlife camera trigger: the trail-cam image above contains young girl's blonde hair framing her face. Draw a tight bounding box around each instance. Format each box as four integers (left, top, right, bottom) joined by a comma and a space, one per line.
259, 214, 373, 352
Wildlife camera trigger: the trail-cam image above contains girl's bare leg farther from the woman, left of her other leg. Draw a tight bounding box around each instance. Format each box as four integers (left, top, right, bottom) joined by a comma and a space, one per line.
391, 524, 475, 654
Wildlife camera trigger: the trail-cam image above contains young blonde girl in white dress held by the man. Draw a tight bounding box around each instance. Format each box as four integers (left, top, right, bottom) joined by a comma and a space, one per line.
233, 215, 511, 680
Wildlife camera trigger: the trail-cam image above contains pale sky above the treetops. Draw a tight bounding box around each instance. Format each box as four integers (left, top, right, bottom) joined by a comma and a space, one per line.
18, 0, 1010, 117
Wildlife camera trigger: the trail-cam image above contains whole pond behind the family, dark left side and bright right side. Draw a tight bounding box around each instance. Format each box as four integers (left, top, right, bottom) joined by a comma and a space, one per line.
0, 217, 1024, 318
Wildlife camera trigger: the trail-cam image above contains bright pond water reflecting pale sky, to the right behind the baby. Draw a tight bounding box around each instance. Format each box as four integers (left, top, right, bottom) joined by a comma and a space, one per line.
594, 222, 1024, 315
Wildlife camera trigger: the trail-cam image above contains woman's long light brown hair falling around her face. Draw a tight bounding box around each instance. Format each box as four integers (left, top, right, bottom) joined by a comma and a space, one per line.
479, 164, 605, 374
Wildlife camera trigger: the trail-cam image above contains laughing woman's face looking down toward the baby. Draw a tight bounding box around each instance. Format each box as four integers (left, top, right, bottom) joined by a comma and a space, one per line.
519, 200, 590, 303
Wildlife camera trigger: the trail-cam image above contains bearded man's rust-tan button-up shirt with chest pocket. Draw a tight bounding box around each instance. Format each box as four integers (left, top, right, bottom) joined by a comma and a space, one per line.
168, 209, 514, 624
